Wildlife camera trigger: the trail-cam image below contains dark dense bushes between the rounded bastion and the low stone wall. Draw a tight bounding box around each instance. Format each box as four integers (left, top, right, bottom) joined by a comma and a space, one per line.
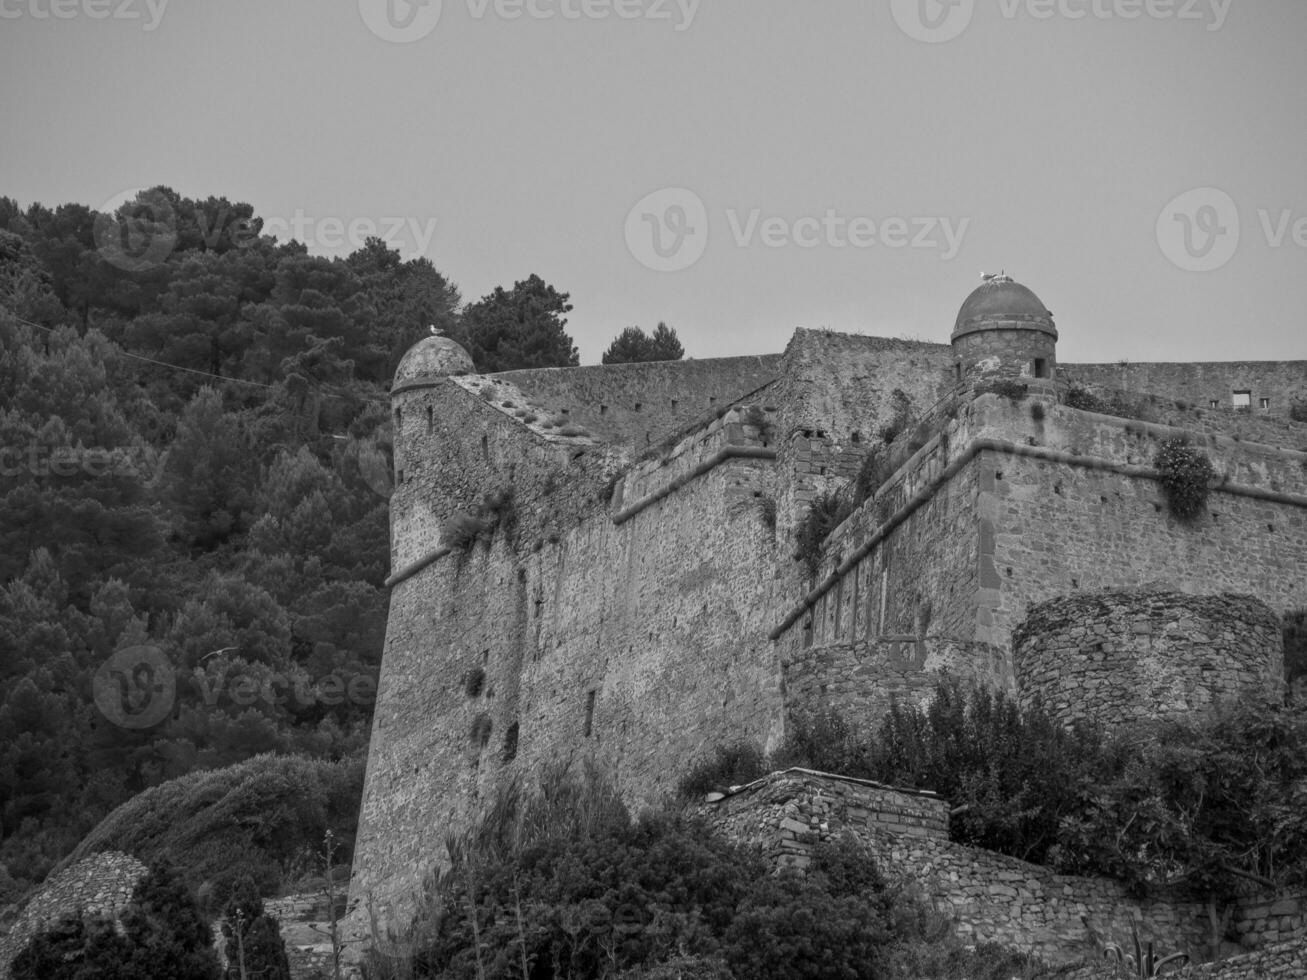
680, 681, 1307, 903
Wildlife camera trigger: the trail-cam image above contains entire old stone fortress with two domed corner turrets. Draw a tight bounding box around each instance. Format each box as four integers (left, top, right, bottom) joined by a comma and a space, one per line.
350, 276, 1307, 961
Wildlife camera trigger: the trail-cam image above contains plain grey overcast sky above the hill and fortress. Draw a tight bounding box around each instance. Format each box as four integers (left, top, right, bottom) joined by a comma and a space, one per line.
0, 0, 1307, 363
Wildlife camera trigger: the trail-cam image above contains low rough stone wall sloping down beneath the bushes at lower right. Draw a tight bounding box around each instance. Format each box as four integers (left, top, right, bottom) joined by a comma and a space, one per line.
704, 770, 1209, 964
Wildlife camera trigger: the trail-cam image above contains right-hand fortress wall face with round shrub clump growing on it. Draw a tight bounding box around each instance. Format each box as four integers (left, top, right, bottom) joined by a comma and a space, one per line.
953, 396, 1307, 644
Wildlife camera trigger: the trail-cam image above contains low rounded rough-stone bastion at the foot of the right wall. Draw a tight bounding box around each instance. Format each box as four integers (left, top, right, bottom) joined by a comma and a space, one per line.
1012, 588, 1283, 725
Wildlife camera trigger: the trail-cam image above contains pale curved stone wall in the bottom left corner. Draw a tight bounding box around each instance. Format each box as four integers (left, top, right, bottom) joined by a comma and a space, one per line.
0, 851, 146, 977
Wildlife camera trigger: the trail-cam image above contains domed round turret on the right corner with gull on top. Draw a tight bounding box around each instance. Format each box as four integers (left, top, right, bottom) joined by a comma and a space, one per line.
951, 274, 1057, 388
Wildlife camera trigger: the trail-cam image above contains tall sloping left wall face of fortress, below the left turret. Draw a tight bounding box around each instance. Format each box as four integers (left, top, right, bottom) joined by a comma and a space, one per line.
350, 402, 783, 930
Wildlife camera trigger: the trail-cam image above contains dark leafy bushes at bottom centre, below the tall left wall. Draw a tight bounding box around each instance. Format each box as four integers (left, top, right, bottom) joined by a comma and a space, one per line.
366, 770, 1048, 980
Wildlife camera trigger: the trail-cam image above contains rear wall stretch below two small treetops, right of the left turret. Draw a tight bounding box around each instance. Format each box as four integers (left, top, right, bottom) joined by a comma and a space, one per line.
491, 354, 782, 452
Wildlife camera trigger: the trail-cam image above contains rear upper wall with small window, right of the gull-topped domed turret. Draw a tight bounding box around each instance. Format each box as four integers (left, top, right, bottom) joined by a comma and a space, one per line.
1059, 361, 1307, 416
